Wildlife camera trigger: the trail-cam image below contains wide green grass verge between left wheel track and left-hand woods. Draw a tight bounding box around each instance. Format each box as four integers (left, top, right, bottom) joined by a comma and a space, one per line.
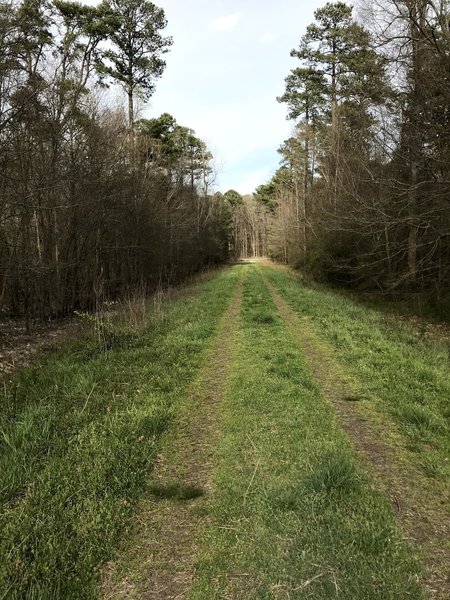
0, 271, 243, 600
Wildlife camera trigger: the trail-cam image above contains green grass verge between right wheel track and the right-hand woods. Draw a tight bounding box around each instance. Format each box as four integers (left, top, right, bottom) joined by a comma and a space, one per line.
264, 268, 450, 483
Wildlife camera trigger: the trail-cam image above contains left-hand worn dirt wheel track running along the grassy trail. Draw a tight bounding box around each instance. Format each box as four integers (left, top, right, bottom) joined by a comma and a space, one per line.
101, 278, 243, 600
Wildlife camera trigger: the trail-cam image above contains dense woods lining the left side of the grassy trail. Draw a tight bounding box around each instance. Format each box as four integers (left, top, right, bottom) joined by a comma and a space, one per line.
0, 0, 229, 319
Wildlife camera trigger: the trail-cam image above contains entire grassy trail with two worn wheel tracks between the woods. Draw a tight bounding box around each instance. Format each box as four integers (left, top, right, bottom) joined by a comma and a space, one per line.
0, 265, 450, 600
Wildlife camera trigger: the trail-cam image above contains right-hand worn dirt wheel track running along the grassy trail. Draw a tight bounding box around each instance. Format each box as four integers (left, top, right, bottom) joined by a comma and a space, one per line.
263, 277, 450, 600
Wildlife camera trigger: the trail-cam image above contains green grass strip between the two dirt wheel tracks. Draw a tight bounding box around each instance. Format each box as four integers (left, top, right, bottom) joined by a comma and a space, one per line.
190, 267, 424, 600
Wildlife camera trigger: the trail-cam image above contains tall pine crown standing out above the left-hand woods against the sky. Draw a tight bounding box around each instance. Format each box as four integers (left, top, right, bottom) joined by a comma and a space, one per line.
100, 0, 172, 129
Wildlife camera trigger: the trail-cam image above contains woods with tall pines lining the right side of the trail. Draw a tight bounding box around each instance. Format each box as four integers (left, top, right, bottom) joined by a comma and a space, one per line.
255, 0, 450, 306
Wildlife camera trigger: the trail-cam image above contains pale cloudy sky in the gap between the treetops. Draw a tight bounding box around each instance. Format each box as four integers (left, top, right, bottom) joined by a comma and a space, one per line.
135, 0, 325, 194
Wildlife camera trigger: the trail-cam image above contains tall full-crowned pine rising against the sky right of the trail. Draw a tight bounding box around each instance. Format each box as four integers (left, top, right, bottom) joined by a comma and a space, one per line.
280, 2, 386, 209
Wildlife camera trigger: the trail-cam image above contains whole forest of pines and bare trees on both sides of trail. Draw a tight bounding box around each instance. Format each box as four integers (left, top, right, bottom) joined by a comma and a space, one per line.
0, 0, 450, 320
